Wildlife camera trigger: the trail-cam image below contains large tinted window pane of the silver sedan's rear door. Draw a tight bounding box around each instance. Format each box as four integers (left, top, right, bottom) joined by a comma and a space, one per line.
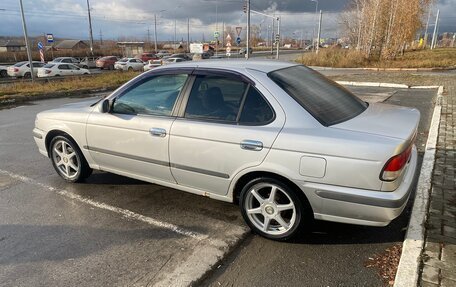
185, 76, 248, 122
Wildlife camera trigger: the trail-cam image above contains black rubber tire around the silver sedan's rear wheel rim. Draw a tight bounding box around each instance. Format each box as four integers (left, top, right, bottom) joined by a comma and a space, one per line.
239, 177, 313, 241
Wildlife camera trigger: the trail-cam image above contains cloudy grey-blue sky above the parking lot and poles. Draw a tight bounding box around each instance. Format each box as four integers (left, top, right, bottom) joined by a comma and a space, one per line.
0, 0, 456, 41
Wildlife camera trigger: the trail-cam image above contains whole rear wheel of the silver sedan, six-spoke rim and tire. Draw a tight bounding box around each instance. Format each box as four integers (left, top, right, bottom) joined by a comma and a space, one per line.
239, 177, 311, 241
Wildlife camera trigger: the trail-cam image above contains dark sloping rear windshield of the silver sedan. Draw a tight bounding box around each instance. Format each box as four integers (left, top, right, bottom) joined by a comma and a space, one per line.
268, 66, 367, 126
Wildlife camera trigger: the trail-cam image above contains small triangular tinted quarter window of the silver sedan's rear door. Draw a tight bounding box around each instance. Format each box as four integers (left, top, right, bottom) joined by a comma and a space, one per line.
239, 87, 274, 125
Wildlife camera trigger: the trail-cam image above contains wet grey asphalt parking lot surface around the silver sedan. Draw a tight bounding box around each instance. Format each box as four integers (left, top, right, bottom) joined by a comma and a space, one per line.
0, 84, 436, 286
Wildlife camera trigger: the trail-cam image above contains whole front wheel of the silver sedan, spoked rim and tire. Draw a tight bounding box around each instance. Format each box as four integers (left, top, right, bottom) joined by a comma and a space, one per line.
49, 135, 92, 182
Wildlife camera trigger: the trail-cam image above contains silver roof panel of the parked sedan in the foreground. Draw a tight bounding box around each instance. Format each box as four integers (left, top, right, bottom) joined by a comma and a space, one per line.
151, 59, 298, 73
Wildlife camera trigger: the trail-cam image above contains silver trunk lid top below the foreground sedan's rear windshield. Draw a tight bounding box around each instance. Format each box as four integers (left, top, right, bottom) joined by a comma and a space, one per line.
331, 103, 420, 140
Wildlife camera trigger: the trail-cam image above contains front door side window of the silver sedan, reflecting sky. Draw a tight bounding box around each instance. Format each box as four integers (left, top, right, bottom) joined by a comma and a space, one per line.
113, 75, 187, 116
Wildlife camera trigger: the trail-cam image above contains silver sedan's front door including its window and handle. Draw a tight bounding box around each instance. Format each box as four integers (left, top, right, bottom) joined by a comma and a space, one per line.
87, 74, 188, 182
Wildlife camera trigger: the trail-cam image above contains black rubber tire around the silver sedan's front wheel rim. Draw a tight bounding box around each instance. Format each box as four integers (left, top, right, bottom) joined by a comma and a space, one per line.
48, 135, 93, 182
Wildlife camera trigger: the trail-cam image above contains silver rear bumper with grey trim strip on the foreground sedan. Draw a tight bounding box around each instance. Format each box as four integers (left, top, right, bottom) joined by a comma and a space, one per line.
300, 147, 418, 226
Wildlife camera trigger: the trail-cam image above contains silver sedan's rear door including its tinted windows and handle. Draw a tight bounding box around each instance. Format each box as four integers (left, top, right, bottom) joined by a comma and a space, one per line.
169, 70, 285, 195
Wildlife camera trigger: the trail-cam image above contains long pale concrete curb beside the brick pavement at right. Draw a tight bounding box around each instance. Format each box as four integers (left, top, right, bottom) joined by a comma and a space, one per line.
394, 86, 443, 287
